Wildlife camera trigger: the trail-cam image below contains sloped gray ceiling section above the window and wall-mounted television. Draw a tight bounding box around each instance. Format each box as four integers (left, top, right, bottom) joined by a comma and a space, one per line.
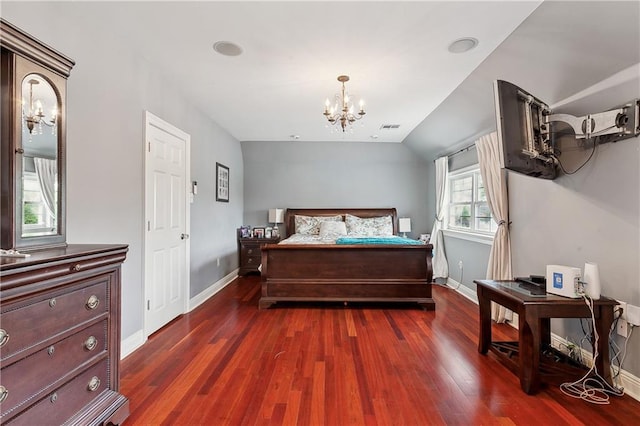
403, 1, 640, 159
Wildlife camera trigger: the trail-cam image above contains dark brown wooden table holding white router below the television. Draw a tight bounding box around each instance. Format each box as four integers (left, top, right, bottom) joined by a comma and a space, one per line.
474, 280, 617, 394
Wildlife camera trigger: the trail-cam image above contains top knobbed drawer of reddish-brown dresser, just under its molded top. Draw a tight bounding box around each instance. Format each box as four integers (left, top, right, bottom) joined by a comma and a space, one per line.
0, 275, 110, 364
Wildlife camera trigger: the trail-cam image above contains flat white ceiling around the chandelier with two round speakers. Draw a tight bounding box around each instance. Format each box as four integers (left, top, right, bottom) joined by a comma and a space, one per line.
66, 1, 540, 142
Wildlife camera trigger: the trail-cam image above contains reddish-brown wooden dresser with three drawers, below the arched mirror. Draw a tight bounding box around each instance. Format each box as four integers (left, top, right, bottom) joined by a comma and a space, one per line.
0, 244, 129, 425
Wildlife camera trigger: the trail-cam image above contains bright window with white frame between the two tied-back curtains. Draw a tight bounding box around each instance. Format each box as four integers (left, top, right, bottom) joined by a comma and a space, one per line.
447, 166, 498, 235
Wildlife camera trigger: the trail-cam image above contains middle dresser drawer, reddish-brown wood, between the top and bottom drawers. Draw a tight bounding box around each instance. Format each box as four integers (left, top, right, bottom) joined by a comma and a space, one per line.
0, 320, 107, 419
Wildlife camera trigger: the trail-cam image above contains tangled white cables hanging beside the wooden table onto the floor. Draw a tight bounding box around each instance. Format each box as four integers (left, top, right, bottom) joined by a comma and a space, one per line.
560, 295, 624, 405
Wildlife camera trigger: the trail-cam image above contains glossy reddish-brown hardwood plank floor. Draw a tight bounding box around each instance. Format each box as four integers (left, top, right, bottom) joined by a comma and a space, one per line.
121, 277, 640, 425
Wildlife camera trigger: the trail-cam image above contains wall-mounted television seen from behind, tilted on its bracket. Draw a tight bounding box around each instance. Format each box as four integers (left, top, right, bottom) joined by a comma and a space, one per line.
494, 80, 557, 179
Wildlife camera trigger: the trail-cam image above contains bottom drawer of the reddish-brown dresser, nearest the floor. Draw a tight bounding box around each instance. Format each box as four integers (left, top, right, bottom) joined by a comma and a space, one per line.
3, 360, 110, 426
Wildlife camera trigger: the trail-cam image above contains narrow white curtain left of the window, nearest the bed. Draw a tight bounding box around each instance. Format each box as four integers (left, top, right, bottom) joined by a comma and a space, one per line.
431, 157, 449, 278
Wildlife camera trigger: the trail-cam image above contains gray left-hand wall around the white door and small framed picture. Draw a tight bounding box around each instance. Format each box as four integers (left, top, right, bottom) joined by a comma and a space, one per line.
2, 2, 244, 339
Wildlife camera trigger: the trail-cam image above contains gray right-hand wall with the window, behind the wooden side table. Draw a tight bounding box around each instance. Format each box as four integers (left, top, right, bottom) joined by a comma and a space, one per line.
429, 71, 640, 376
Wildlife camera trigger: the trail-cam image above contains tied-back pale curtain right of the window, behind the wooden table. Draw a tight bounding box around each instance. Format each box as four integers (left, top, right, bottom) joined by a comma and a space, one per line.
476, 132, 513, 322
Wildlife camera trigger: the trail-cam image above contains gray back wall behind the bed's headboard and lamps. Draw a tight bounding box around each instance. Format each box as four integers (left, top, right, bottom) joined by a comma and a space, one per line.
241, 141, 431, 237
